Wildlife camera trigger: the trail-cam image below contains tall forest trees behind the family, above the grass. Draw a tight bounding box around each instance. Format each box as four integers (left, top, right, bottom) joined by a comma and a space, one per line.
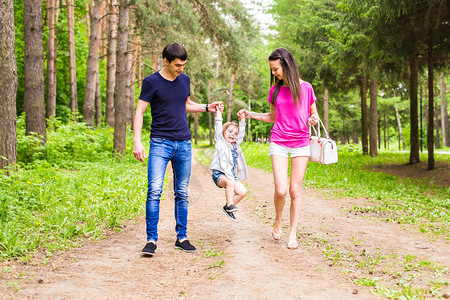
0, 0, 450, 169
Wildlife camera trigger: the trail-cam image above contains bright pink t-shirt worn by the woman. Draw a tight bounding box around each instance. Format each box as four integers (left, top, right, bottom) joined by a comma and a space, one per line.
267, 81, 316, 148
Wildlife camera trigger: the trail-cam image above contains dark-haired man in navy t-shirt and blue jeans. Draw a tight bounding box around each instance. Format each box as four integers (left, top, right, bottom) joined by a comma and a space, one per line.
133, 43, 223, 256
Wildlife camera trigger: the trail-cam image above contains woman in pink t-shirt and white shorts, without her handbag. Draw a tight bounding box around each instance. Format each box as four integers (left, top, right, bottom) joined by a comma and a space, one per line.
238, 48, 319, 249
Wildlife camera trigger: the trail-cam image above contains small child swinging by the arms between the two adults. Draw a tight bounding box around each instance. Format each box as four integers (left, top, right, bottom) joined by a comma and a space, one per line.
210, 111, 248, 221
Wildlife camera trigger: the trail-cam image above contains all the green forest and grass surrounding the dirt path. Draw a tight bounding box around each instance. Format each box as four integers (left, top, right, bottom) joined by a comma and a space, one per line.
0, 0, 450, 295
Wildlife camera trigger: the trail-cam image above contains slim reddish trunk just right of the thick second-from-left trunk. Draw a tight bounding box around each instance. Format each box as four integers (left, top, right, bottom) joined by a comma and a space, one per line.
47, 0, 56, 119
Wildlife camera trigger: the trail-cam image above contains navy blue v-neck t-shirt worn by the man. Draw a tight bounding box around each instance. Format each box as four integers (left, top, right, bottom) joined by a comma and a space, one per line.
139, 72, 191, 141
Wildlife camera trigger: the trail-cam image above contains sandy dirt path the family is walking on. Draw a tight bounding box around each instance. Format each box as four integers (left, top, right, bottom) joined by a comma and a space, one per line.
0, 151, 450, 299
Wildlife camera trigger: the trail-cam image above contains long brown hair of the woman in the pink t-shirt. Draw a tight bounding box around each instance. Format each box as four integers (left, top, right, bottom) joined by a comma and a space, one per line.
269, 48, 301, 106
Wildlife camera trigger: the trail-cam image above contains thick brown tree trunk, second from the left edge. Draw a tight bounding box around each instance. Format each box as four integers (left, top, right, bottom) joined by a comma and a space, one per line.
23, 0, 47, 144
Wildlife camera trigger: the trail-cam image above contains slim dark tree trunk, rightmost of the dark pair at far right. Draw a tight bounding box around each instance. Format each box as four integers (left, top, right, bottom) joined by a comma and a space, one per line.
427, 45, 434, 170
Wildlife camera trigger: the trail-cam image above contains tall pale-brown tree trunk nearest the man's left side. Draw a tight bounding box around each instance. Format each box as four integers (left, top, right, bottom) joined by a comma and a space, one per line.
114, 0, 130, 155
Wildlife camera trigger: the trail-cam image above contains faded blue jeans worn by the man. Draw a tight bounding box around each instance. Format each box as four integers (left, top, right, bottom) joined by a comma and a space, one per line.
146, 138, 191, 243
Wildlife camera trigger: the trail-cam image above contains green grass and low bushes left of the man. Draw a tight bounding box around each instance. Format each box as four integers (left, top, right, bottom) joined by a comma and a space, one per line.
0, 119, 146, 259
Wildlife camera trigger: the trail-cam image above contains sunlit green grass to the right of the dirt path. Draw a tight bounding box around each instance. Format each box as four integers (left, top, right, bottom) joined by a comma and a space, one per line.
242, 143, 450, 239
